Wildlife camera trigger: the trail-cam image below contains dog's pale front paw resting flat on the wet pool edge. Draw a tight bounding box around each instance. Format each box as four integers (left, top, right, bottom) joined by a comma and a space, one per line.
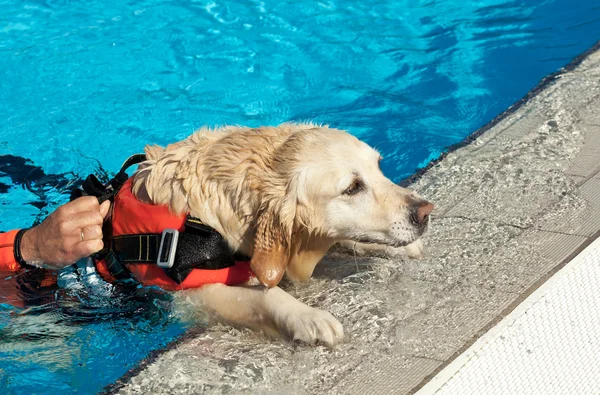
275, 306, 344, 346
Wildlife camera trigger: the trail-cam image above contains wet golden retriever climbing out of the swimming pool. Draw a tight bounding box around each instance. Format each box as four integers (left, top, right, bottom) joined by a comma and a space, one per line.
133, 123, 433, 345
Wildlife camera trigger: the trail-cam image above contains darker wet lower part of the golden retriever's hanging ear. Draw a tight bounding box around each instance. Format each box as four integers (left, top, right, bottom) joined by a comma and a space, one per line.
250, 210, 291, 288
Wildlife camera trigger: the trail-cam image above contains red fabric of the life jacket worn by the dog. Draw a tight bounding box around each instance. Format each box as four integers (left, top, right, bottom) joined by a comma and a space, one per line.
96, 178, 254, 291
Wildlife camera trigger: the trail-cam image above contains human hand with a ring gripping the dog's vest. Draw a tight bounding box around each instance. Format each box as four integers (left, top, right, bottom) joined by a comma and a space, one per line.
21, 196, 110, 270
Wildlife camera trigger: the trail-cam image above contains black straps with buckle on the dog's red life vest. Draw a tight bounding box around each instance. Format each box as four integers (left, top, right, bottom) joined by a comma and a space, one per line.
72, 154, 250, 284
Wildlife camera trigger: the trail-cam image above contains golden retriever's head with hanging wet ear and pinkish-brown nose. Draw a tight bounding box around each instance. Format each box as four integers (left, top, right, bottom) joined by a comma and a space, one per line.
252, 128, 433, 286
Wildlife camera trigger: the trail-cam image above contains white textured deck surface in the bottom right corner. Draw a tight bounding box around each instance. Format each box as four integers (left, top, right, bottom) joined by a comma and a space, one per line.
417, 239, 600, 395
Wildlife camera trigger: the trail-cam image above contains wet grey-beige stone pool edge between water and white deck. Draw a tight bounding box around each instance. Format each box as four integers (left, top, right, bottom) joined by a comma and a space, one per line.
110, 43, 600, 393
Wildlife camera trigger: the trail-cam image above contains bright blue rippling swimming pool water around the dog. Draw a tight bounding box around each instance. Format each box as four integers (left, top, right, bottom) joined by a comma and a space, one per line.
0, 0, 600, 393
